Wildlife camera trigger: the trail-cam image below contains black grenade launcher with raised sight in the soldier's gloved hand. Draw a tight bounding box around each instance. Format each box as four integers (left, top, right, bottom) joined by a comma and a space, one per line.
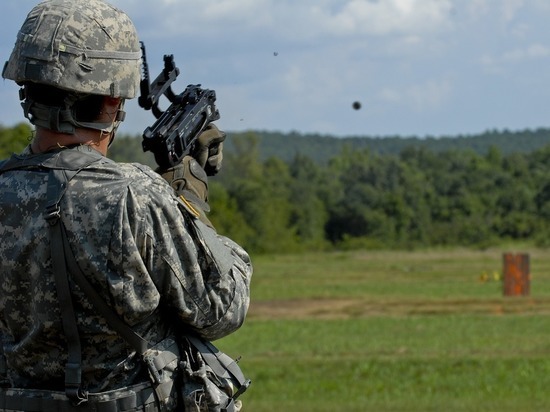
138, 42, 220, 169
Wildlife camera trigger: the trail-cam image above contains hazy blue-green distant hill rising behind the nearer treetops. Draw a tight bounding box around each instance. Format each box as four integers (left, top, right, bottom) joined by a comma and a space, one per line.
225, 128, 550, 163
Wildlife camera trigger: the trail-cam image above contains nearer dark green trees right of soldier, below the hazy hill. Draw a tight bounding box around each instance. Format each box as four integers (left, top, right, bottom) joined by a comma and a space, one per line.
213, 136, 550, 252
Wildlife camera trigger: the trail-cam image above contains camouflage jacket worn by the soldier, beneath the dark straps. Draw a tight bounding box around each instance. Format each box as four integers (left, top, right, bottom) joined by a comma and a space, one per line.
0, 146, 252, 392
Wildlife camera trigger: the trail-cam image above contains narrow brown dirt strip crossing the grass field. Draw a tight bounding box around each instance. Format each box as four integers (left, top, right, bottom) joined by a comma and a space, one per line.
248, 298, 550, 319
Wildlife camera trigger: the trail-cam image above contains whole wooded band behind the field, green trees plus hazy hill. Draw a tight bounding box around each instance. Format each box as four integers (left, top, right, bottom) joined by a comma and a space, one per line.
0, 120, 550, 253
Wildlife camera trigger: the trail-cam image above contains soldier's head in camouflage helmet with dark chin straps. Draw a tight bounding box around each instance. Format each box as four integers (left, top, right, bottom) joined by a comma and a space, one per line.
2, 0, 141, 134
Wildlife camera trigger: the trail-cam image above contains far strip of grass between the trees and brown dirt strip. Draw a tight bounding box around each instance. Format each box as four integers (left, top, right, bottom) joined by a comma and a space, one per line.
253, 250, 550, 300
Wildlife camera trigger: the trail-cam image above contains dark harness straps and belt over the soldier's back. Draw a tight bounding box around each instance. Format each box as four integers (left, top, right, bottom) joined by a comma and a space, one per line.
0, 147, 179, 412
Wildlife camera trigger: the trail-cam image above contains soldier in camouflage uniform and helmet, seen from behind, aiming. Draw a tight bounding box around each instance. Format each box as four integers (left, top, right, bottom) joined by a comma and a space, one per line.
0, 0, 252, 411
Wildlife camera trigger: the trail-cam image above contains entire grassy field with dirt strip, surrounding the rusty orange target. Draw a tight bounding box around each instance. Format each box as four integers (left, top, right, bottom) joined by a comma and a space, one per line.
218, 249, 550, 412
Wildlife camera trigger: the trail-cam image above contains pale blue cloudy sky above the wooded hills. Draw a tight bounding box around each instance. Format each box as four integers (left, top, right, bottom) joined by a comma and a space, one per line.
0, 0, 550, 137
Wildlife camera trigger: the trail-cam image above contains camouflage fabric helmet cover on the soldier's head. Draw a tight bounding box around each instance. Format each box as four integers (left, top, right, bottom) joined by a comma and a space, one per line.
2, 0, 141, 99
